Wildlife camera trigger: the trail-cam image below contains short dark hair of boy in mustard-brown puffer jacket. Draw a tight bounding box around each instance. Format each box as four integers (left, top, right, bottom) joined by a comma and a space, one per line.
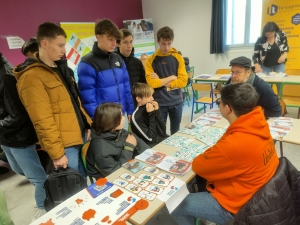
36, 22, 67, 46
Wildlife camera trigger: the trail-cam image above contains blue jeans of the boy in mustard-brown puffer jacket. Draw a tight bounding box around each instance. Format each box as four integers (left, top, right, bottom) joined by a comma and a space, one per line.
65, 145, 86, 178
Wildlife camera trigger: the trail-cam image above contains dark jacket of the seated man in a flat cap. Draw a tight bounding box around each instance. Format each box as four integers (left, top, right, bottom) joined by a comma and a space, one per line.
226, 74, 281, 118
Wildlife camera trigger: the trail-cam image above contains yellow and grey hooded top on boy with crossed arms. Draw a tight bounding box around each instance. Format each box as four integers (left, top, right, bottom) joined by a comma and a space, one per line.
145, 48, 188, 106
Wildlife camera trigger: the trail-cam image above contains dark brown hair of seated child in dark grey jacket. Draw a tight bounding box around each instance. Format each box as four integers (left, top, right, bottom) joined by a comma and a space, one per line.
92, 103, 122, 135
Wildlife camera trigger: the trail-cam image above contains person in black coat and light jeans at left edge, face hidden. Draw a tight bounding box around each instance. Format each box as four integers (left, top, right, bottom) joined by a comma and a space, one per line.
0, 53, 47, 216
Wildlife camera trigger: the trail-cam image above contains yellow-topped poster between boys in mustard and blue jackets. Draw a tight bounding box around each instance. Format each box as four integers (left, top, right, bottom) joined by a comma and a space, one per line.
60, 22, 96, 82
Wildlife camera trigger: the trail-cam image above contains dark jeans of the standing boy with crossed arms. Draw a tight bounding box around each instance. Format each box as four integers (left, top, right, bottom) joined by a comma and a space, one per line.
159, 102, 183, 135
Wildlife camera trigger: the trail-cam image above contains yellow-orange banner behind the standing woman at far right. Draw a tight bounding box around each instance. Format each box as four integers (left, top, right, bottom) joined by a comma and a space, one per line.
262, 0, 300, 69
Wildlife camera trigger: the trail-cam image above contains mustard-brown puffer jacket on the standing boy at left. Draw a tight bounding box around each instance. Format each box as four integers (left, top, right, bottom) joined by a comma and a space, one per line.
13, 53, 92, 160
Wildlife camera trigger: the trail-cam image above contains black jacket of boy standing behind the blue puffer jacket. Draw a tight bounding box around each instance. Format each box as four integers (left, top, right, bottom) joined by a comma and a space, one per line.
115, 47, 146, 89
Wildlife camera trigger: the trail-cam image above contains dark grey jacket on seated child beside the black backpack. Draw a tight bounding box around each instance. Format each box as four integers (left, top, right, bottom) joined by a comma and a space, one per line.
86, 129, 149, 179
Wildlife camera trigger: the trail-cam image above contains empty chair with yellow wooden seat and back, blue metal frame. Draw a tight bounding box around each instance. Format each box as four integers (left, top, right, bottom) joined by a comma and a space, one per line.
191, 82, 216, 121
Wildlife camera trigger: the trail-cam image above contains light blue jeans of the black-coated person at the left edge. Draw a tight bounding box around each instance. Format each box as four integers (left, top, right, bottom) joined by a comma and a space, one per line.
1, 145, 47, 209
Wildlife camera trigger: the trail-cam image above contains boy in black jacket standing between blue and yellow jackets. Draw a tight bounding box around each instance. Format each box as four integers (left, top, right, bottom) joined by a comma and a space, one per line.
115, 29, 146, 88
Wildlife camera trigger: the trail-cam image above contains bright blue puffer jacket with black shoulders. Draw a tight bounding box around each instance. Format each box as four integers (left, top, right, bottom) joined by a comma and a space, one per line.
78, 42, 134, 118
